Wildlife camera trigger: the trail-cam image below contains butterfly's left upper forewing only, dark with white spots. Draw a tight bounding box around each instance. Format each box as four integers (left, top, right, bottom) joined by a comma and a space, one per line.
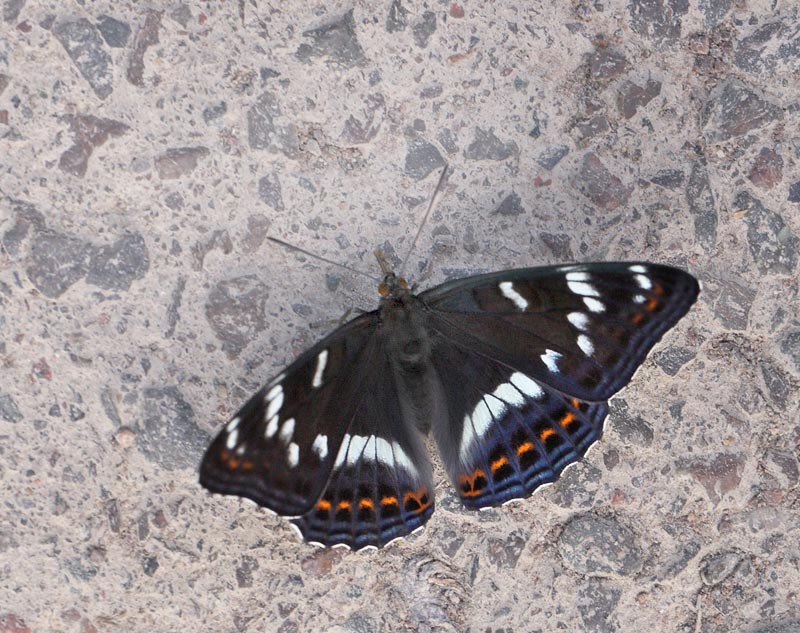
200, 313, 378, 516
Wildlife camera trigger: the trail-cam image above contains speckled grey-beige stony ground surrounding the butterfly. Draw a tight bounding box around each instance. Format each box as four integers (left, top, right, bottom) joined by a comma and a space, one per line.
0, 0, 800, 633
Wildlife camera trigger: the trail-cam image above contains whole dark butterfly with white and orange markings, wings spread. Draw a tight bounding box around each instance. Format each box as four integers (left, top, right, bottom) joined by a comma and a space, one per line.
200, 262, 699, 549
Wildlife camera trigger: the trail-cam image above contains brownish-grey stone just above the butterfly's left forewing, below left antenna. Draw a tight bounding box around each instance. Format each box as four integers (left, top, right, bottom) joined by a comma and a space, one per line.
206, 275, 269, 356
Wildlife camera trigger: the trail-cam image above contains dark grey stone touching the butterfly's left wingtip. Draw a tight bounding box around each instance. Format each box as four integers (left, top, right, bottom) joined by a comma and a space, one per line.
135, 385, 211, 470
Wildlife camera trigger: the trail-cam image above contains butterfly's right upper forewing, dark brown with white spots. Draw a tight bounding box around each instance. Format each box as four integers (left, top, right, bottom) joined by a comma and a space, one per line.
419, 263, 699, 402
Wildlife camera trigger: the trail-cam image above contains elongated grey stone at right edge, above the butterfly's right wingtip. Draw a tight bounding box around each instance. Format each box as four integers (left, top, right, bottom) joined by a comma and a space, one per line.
734, 191, 800, 274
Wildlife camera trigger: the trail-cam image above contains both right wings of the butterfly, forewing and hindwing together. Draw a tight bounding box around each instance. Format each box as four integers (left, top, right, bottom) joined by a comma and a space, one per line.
420, 263, 699, 508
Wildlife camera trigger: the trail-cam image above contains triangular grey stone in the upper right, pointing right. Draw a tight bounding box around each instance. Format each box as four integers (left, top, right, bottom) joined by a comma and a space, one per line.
703, 79, 783, 143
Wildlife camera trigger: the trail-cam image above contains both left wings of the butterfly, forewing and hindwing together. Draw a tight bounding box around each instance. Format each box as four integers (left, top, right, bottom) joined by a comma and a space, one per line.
200, 312, 433, 549
